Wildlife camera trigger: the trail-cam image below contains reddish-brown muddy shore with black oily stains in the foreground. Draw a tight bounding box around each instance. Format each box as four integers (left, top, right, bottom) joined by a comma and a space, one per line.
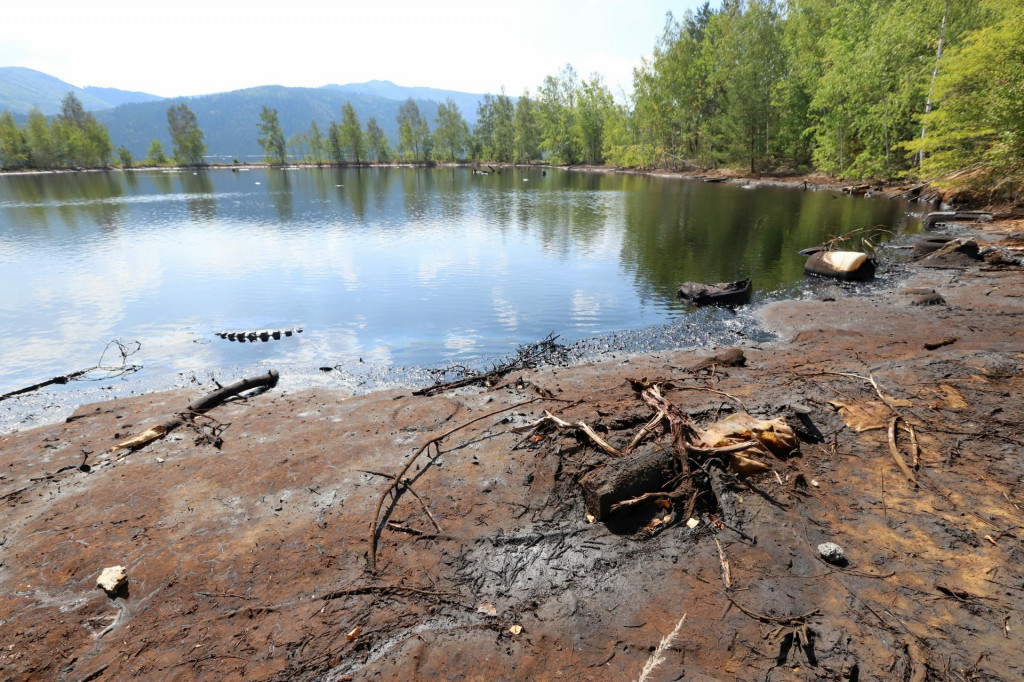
0, 220, 1024, 682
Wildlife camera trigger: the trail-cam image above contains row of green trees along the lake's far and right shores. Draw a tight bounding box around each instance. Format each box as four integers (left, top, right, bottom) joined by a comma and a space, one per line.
0, 0, 1024, 195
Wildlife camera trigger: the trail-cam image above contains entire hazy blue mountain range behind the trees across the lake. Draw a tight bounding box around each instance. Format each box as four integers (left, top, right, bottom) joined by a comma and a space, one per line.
0, 67, 491, 162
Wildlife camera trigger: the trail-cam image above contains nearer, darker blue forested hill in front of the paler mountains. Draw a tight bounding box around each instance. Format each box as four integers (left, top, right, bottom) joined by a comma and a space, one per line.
96, 85, 437, 157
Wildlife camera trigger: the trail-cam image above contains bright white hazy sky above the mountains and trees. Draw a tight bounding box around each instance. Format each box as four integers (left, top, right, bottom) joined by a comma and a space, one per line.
0, 0, 717, 97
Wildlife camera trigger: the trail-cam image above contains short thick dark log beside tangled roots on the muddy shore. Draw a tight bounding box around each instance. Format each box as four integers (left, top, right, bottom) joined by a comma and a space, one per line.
580, 443, 683, 520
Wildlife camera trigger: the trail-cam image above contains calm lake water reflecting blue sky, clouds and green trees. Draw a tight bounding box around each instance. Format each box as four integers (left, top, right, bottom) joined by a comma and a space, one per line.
0, 168, 918, 419
